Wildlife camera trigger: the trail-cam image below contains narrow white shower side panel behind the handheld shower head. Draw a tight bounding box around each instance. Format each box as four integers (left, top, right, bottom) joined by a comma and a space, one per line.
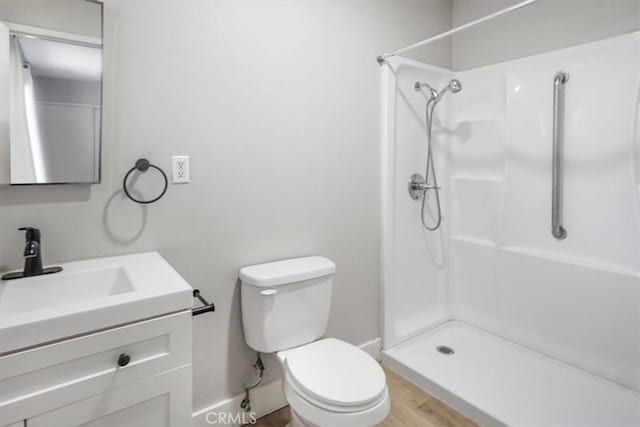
382, 57, 452, 348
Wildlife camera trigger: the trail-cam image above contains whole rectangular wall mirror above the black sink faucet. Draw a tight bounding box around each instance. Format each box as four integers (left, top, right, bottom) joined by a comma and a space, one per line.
0, 0, 102, 184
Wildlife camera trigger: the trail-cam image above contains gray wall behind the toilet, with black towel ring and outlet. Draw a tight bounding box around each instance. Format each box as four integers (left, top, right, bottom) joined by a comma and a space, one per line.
0, 0, 451, 414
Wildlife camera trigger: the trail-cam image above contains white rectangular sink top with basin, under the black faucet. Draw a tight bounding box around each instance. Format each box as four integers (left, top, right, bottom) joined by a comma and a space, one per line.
0, 252, 192, 354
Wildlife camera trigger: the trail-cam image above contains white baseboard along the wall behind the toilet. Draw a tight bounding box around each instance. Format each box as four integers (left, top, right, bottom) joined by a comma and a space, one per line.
193, 338, 382, 427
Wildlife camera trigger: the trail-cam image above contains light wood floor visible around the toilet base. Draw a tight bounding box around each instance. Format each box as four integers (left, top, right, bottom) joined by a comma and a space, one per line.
254, 367, 477, 427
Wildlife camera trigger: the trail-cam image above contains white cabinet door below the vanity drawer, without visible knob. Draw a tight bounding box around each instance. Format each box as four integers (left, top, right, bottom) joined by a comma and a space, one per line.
27, 365, 191, 427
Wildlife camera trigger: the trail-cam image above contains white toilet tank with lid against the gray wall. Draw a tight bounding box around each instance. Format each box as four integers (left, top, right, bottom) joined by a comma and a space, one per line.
240, 256, 336, 353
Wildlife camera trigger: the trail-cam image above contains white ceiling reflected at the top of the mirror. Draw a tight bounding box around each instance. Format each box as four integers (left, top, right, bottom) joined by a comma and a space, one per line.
18, 36, 102, 81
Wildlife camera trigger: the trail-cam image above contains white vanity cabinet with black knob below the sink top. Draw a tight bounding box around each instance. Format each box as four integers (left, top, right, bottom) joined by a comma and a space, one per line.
0, 310, 192, 427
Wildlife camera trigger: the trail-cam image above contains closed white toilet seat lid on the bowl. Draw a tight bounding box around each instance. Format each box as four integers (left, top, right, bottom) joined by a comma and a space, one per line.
284, 338, 388, 413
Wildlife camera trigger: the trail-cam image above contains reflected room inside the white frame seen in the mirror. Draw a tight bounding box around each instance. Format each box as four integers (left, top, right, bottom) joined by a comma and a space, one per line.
9, 34, 102, 184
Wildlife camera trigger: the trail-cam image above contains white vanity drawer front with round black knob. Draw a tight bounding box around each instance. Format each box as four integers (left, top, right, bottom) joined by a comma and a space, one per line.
0, 310, 191, 426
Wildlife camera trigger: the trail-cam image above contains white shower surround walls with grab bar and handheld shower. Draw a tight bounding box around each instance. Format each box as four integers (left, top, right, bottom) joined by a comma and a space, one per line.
382, 33, 640, 425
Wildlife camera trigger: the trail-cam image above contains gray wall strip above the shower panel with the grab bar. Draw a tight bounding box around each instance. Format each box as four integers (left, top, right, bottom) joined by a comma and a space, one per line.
452, 0, 640, 70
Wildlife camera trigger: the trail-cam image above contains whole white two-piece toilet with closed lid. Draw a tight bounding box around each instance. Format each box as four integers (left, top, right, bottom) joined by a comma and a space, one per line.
240, 256, 390, 427
